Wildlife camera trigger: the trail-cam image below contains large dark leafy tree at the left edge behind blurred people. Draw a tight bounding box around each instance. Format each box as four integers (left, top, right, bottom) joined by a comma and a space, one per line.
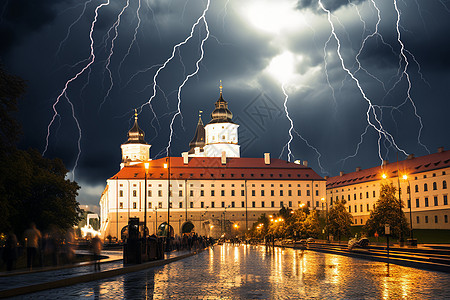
0, 65, 81, 235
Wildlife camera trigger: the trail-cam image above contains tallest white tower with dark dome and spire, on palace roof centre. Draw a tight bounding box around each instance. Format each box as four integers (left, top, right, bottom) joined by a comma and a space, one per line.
204, 82, 240, 157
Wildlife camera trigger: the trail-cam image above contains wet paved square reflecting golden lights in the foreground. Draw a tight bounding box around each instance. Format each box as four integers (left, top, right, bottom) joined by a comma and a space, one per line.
7, 245, 450, 299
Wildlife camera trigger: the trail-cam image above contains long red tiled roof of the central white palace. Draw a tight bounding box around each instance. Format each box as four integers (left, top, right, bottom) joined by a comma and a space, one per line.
111, 157, 325, 180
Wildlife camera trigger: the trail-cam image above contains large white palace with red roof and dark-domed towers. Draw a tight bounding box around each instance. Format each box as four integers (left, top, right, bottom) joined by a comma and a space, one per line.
100, 87, 326, 239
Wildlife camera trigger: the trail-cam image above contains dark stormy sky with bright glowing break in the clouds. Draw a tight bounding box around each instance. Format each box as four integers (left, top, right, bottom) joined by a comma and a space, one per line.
0, 0, 450, 209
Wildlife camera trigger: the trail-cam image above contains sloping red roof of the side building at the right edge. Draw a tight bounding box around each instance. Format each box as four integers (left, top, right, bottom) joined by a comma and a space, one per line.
327, 150, 450, 189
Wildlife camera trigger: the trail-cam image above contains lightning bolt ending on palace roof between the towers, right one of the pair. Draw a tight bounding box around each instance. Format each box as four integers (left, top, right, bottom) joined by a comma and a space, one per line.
166, 0, 210, 156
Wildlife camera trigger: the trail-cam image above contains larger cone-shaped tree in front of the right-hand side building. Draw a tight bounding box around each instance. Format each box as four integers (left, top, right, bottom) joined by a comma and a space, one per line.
364, 183, 409, 239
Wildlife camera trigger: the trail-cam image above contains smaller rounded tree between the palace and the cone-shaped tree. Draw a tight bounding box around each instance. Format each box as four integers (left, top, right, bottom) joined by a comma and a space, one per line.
327, 200, 353, 241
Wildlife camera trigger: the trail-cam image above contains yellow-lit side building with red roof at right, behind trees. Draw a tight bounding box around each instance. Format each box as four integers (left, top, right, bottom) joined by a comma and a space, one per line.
326, 148, 450, 229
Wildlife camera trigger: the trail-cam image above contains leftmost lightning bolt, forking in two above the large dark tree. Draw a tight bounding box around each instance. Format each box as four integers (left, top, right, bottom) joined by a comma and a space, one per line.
42, 0, 110, 180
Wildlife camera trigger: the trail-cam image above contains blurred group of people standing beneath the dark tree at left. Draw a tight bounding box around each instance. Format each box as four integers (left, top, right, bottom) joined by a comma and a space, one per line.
2, 223, 75, 271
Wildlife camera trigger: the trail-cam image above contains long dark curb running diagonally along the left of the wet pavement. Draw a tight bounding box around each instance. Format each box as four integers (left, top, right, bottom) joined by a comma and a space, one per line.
0, 251, 201, 298
